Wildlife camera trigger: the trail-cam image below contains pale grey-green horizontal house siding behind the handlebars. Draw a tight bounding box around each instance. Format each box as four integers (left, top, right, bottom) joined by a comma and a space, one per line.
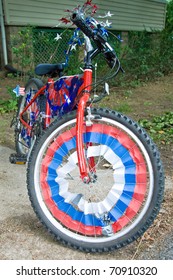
3, 0, 166, 31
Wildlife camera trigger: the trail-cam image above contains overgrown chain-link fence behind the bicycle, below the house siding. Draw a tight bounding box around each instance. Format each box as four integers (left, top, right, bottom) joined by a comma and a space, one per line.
11, 26, 120, 80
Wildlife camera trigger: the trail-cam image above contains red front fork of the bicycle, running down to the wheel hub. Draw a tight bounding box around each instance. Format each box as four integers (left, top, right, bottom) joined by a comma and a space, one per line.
76, 69, 95, 183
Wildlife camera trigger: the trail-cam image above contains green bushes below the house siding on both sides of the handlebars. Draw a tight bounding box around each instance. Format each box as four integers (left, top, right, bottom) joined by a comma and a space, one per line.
12, 0, 173, 83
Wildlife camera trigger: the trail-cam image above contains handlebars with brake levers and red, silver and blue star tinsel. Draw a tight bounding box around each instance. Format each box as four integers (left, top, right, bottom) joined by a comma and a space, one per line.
58, 1, 124, 76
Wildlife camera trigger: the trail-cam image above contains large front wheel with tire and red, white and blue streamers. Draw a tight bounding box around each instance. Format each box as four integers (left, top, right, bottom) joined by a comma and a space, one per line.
27, 109, 164, 252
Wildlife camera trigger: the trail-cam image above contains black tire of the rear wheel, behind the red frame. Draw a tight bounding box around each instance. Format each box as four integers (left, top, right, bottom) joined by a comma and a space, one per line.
15, 78, 46, 156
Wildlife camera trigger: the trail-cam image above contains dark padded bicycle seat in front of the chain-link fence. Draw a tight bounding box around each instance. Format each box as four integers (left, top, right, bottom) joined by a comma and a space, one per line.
35, 63, 65, 77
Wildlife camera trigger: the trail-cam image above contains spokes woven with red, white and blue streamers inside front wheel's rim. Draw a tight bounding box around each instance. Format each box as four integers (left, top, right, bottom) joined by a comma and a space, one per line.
38, 115, 153, 242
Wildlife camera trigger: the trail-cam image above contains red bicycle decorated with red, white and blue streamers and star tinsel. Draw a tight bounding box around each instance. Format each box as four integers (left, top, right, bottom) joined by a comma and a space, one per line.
13, 1, 164, 252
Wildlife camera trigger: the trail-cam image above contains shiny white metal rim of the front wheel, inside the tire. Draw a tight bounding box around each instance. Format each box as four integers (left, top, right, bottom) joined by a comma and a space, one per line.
34, 117, 154, 243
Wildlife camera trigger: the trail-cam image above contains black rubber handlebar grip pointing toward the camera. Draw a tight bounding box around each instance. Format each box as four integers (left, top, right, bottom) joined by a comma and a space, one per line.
71, 13, 94, 38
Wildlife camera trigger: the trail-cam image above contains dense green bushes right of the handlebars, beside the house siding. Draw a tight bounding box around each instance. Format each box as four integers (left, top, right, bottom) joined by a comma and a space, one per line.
117, 0, 173, 80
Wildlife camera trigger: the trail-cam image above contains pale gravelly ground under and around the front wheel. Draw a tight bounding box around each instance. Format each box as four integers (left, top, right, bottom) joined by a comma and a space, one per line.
0, 146, 173, 260
